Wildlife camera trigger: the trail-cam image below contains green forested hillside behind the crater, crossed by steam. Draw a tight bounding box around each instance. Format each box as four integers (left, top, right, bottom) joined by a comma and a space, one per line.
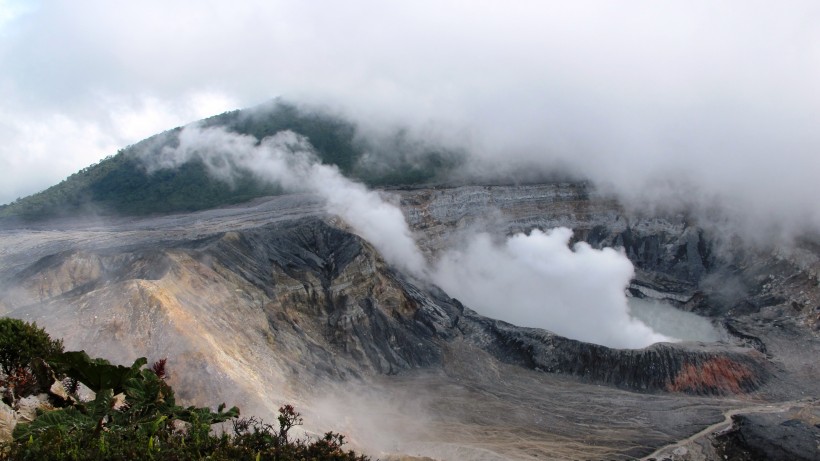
0, 101, 460, 221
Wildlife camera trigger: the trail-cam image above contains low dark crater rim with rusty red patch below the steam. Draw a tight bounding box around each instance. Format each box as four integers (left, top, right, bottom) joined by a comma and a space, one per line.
459, 313, 770, 395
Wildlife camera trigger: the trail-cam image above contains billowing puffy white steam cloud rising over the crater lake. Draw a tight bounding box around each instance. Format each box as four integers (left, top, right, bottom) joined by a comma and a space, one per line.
433, 227, 672, 348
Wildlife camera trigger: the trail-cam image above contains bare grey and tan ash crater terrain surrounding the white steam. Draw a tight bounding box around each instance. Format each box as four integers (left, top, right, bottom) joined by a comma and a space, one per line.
0, 184, 820, 459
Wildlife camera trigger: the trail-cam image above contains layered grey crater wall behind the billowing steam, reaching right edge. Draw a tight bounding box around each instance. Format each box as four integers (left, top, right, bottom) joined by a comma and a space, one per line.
400, 183, 820, 331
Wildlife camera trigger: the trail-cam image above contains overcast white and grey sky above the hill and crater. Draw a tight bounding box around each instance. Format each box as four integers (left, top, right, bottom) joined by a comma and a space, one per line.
0, 0, 820, 237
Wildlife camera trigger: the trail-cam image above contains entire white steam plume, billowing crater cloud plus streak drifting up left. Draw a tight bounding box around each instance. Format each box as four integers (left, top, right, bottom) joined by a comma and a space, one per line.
151, 126, 672, 348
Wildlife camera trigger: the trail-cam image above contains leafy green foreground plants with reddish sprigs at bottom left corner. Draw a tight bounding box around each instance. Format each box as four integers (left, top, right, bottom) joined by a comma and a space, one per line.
0, 351, 368, 461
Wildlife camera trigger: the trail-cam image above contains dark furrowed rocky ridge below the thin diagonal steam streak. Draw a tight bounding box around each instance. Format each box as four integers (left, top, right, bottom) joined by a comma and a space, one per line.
194, 218, 448, 374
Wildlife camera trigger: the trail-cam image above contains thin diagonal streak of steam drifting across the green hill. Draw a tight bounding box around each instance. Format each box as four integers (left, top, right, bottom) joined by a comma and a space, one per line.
153, 126, 425, 276
